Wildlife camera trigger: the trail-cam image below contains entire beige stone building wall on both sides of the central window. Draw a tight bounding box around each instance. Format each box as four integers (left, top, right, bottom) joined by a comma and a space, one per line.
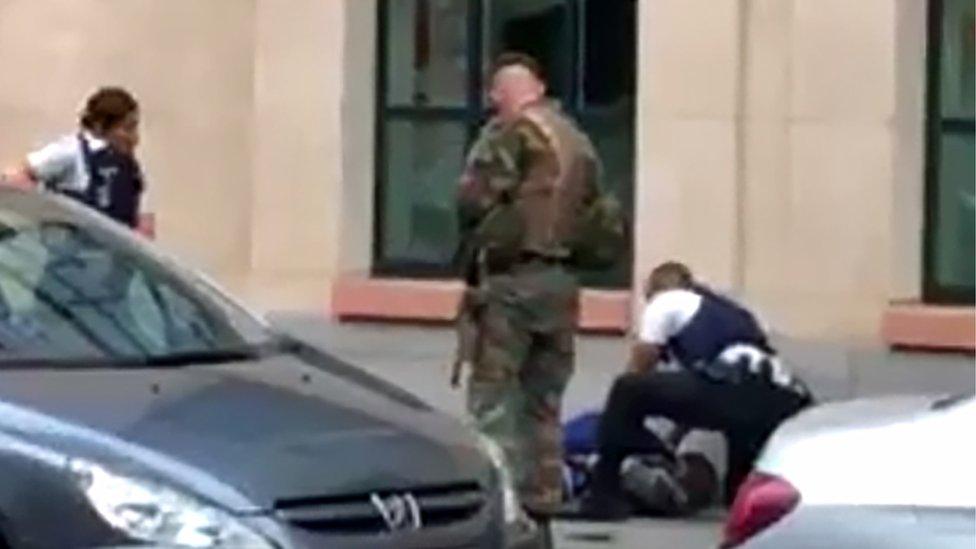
0, 0, 925, 339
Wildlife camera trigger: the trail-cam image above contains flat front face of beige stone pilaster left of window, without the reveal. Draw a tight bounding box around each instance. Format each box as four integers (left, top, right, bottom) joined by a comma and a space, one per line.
248, 0, 344, 307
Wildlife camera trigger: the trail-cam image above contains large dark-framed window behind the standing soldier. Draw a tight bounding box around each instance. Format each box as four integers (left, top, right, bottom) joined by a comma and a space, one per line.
373, 0, 636, 287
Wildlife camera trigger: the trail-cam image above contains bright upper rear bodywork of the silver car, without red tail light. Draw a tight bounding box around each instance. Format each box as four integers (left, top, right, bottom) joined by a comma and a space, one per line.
757, 396, 976, 507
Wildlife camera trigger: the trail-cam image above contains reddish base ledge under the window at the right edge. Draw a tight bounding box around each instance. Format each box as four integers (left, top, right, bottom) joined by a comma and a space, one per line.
881, 303, 976, 352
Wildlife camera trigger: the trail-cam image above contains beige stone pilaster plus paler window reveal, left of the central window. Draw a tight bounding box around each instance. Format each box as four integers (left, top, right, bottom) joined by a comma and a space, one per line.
245, 0, 376, 311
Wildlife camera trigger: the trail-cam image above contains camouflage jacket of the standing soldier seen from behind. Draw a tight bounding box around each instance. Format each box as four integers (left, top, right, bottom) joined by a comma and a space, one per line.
458, 102, 599, 274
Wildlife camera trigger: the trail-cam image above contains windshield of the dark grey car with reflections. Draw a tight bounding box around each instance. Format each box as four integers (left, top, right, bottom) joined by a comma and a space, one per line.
0, 190, 275, 366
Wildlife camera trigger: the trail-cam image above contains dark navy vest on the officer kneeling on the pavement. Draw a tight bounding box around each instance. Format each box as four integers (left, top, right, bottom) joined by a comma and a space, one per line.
667, 287, 773, 367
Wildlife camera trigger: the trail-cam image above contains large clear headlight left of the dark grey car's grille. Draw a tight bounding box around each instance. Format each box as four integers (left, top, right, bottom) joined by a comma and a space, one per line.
68, 459, 273, 549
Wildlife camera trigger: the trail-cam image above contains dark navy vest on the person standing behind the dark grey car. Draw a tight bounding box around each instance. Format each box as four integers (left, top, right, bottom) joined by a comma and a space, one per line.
61, 135, 143, 228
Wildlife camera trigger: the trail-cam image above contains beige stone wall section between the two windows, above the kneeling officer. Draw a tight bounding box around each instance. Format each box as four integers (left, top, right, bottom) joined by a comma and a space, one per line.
636, 0, 925, 340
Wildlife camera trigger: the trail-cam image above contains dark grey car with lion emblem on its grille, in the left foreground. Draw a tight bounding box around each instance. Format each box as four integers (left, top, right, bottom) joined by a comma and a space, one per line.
0, 190, 538, 549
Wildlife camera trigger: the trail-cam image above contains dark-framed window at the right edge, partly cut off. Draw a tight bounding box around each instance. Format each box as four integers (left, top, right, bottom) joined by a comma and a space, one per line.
923, 0, 976, 304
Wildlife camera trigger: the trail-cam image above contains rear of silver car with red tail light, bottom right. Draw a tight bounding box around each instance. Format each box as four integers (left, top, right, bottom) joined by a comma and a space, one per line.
722, 395, 976, 549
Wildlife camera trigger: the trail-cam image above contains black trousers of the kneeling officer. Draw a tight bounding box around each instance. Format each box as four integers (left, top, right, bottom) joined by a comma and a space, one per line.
594, 370, 811, 502
